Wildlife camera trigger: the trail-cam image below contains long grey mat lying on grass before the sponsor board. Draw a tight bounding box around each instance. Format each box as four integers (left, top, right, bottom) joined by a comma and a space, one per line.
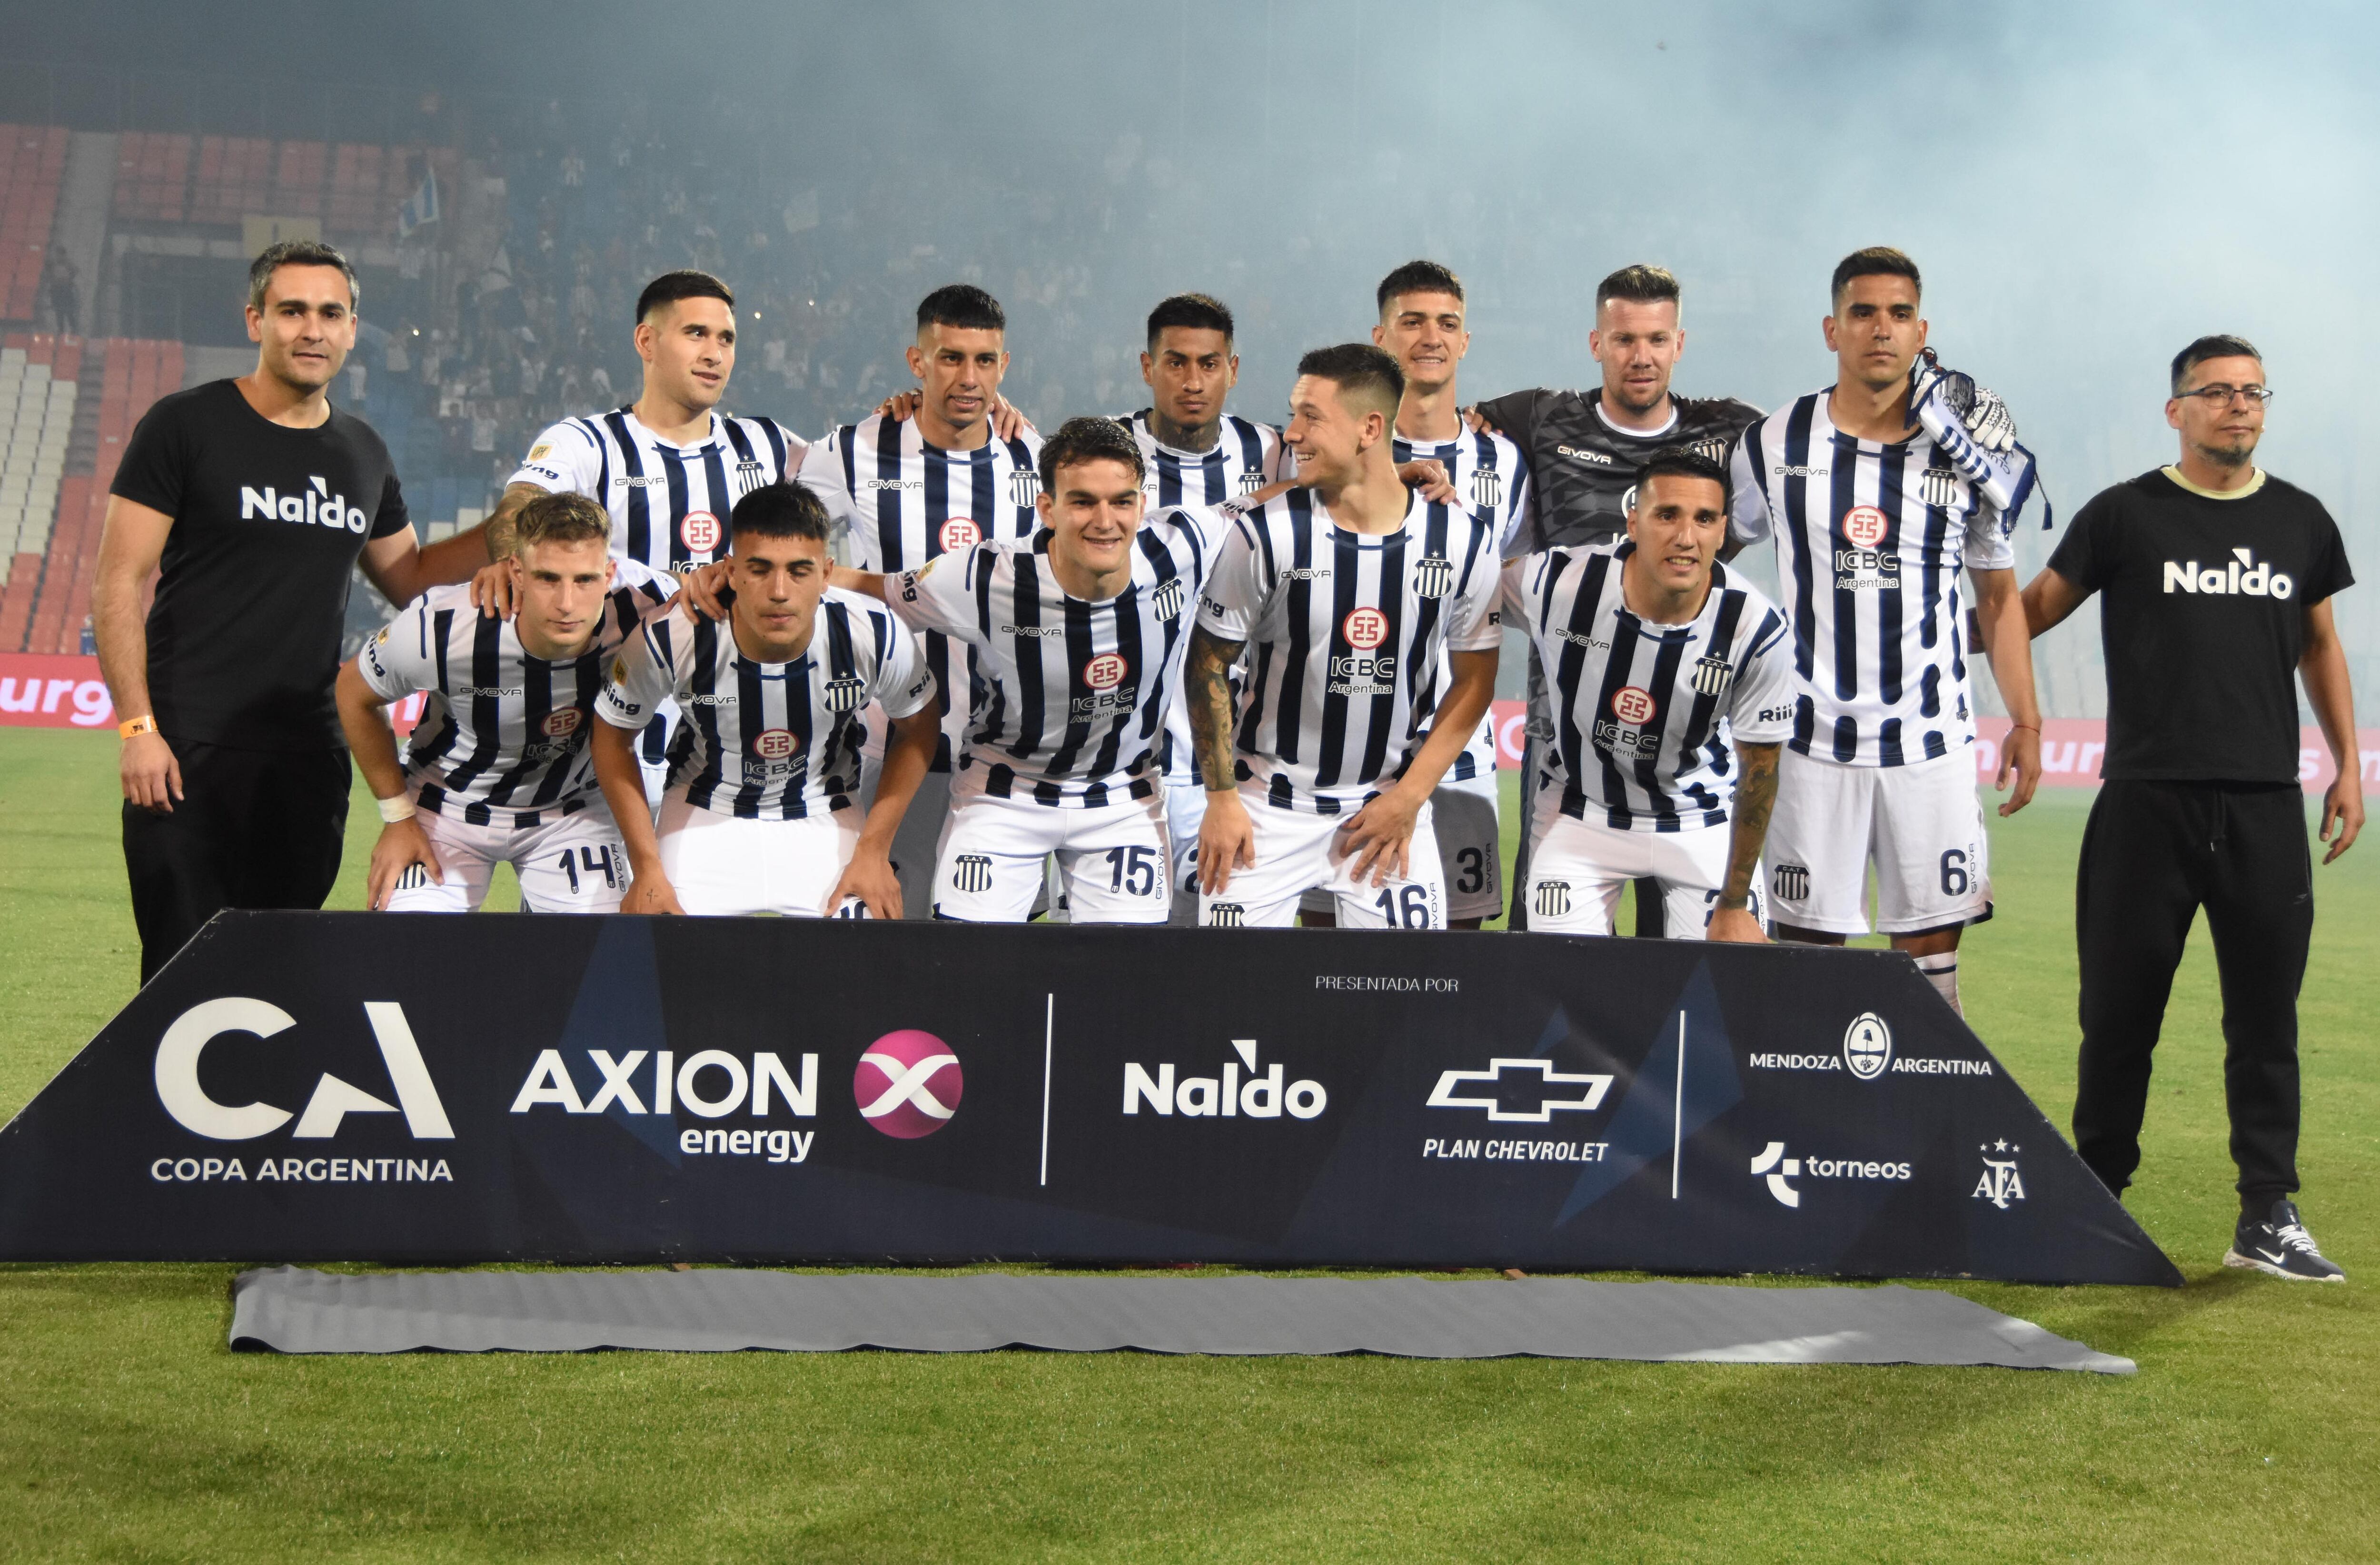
231, 1268, 2132, 1375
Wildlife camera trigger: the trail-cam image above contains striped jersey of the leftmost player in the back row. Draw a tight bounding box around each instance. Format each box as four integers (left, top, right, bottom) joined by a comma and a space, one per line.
507, 406, 809, 573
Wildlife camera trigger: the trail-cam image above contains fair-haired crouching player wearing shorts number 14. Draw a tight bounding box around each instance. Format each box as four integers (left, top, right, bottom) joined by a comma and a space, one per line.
338, 495, 676, 913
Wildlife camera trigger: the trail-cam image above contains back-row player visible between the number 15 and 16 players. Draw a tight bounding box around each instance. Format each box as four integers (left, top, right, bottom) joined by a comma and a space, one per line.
1119, 293, 1283, 923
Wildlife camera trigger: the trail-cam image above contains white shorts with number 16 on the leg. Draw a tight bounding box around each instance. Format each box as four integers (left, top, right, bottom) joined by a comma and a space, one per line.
1197, 782, 1447, 930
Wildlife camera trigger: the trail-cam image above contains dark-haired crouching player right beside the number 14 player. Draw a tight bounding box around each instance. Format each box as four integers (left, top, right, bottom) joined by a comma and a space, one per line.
595, 483, 940, 918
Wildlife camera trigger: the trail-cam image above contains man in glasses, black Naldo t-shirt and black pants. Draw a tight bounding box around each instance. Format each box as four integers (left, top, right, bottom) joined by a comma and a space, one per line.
2025, 338, 2363, 1282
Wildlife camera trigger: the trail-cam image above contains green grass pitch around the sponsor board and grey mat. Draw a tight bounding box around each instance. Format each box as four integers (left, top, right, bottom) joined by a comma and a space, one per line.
0, 730, 2380, 1563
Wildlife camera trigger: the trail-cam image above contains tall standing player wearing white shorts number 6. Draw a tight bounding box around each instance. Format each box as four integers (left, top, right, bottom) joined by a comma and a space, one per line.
1735, 248, 2042, 1009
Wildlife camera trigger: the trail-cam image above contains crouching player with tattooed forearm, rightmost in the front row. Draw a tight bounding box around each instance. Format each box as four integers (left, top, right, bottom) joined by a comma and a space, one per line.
1504, 447, 1792, 942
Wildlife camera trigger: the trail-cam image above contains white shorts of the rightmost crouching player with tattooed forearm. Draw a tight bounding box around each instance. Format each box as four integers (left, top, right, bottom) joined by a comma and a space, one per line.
1521, 787, 1761, 940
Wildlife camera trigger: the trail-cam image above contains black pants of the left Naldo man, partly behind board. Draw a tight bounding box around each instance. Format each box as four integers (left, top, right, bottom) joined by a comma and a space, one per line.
124, 737, 350, 982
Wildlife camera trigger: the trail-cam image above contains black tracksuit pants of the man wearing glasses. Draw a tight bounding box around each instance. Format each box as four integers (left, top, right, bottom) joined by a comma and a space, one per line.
2075, 782, 2313, 1210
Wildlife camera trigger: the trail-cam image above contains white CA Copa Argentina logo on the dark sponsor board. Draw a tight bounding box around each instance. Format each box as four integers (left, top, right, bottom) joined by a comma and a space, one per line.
150, 994, 455, 1184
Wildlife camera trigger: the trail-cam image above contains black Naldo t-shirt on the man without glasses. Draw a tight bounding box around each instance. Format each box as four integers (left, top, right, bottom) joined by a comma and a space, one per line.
112, 381, 412, 749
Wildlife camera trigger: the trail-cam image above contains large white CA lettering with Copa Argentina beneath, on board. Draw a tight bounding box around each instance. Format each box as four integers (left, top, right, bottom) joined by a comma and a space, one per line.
148, 994, 455, 1184
